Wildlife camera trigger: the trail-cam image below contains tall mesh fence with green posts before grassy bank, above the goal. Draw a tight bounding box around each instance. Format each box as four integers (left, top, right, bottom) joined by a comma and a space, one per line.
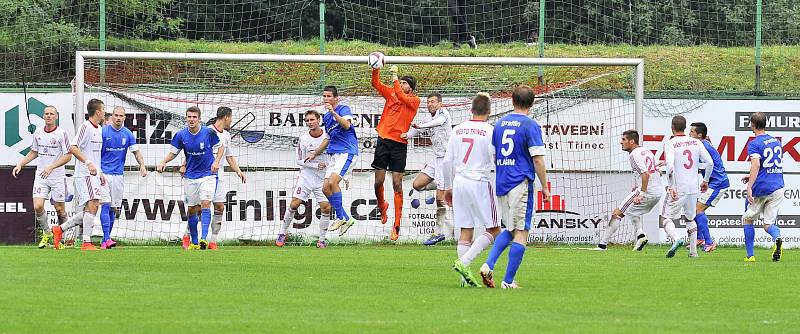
0, 0, 800, 97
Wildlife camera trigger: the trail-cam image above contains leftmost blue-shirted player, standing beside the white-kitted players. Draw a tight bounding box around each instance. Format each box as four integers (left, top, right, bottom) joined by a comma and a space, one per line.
100, 107, 147, 249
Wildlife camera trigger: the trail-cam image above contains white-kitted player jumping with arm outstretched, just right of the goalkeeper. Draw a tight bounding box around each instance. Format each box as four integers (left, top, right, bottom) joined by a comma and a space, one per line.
400, 93, 453, 246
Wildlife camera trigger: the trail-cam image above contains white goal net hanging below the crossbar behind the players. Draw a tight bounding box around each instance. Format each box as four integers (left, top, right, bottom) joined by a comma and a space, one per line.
70, 52, 643, 244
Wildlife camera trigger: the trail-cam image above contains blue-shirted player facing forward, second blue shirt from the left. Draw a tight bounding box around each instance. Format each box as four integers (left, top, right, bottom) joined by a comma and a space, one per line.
157, 107, 225, 249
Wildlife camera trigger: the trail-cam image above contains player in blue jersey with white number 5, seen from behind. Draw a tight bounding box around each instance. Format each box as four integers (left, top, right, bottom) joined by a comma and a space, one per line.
481, 86, 550, 289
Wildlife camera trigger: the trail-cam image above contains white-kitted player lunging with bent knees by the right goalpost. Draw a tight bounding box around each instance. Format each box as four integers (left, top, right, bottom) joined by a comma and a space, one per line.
597, 130, 664, 251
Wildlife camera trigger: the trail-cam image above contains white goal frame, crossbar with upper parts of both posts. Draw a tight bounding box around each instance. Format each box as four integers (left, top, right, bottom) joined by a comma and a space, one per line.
75, 51, 644, 133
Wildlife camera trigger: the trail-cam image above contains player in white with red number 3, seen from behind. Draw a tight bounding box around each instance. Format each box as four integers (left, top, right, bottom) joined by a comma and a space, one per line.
661, 115, 714, 258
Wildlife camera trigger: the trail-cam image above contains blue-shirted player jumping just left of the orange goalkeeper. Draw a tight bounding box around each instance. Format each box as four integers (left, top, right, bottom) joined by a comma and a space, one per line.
305, 86, 358, 236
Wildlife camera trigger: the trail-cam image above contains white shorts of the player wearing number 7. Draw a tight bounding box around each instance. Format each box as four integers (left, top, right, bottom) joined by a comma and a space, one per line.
453, 176, 500, 228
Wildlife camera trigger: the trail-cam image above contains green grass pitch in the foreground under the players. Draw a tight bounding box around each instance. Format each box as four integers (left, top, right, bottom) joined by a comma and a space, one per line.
0, 245, 800, 333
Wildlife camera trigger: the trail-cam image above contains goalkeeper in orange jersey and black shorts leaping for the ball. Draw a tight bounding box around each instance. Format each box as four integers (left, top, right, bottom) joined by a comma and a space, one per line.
372, 65, 420, 241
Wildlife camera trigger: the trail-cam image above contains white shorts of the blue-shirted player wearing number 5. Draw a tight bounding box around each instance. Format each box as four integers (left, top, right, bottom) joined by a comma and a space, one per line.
497, 179, 536, 231
